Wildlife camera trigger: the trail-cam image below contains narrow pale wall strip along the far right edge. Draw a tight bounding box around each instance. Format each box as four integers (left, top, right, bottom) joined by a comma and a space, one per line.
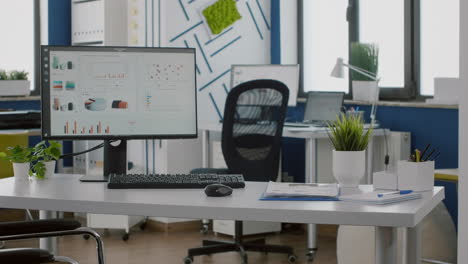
458, 1, 468, 263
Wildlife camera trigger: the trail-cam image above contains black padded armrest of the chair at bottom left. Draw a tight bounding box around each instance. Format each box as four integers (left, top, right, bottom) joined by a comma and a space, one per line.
0, 219, 81, 236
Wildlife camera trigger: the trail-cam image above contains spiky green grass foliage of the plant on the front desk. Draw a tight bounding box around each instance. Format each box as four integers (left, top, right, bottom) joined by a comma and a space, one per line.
328, 113, 372, 151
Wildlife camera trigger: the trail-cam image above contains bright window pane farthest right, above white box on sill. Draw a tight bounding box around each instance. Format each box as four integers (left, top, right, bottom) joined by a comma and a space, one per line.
420, 0, 460, 95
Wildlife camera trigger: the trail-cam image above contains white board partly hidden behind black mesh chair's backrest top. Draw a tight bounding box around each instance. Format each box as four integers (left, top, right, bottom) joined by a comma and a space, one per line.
231, 64, 299, 106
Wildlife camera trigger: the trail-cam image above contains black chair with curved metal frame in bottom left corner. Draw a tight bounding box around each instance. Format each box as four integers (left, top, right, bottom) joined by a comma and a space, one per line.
0, 219, 104, 264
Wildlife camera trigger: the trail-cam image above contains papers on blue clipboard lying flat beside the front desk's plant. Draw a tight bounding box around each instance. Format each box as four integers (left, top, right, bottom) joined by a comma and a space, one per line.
261, 182, 339, 201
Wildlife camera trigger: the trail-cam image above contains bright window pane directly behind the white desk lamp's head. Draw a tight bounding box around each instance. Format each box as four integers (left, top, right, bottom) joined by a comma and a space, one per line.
302, 0, 349, 92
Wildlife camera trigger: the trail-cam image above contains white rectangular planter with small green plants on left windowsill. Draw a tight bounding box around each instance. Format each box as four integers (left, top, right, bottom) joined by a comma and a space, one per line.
0, 70, 31, 96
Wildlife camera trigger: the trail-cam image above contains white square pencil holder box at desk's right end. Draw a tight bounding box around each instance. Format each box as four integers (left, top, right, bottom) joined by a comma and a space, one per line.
397, 160, 434, 192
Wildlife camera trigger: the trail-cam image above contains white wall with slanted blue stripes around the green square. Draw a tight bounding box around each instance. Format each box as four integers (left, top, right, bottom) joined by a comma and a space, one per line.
161, 0, 271, 123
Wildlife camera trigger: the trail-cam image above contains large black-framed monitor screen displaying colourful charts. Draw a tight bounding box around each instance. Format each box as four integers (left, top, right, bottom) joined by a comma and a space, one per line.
41, 46, 197, 139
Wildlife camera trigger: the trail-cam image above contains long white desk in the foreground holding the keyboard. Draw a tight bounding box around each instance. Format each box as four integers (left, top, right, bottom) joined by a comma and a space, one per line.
0, 174, 444, 264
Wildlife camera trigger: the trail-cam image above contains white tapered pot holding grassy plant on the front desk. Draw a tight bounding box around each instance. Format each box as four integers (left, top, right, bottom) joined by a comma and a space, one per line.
333, 150, 366, 188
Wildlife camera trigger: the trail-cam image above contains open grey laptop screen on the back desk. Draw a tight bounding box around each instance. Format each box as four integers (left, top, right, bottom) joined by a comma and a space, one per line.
304, 92, 344, 122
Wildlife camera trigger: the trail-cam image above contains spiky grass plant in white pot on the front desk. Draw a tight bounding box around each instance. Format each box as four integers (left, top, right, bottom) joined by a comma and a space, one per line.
328, 114, 372, 188
